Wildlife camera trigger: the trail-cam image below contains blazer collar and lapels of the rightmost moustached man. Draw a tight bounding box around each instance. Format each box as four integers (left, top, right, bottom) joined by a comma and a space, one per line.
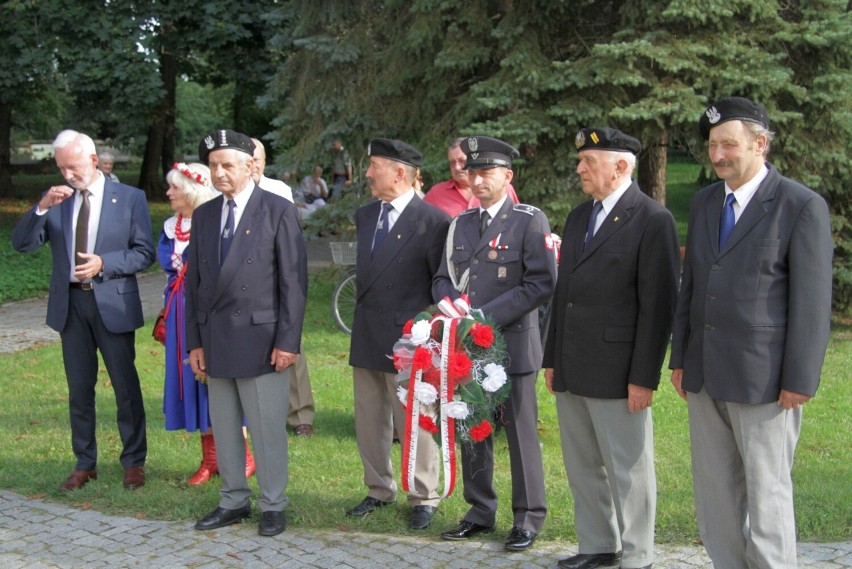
704, 162, 781, 257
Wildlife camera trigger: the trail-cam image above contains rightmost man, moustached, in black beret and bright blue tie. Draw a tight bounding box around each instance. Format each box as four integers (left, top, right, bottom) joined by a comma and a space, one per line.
669, 97, 833, 569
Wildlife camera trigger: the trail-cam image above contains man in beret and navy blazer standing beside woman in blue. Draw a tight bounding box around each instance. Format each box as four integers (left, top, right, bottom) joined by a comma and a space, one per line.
186, 130, 307, 536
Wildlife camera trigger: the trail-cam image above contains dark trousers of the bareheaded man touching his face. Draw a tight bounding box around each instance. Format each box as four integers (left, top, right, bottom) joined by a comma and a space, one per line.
59, 288, 148, 470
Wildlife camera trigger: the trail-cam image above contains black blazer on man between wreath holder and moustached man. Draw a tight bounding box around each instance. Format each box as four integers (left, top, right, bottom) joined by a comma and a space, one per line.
544, 182, 680, 399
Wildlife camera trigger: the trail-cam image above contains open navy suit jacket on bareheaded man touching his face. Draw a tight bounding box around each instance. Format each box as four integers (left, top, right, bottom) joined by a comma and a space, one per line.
12, 179, 155, 334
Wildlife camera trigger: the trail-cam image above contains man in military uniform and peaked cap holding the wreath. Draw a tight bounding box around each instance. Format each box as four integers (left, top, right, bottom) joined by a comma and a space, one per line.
432, 136, 556, 551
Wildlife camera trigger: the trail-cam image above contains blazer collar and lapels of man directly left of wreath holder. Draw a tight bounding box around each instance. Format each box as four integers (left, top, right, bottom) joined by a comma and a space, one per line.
356, 196, 423, 298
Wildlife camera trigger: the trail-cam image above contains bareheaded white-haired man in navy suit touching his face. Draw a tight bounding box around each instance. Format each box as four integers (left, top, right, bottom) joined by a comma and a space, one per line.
12, 130, 155, 492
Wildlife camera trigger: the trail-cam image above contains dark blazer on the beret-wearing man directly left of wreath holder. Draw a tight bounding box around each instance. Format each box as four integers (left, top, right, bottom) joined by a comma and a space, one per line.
349, 196, 450, 373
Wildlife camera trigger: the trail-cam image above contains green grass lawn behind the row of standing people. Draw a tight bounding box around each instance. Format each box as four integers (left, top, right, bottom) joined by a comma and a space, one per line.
0, 168, 852, 543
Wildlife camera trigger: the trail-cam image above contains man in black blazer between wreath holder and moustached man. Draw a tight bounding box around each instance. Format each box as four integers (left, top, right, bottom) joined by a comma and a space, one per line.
543, 127, 680, 569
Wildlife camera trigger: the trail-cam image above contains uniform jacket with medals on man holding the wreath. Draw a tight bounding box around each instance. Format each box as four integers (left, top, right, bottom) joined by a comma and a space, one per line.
432, 199, 556, 374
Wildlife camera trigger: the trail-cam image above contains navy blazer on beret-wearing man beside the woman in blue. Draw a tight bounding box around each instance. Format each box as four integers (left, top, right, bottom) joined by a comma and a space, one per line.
185, 187, 308, 378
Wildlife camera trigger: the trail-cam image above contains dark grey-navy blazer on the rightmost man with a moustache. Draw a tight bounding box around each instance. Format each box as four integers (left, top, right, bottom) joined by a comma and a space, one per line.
669, 164, 834, 404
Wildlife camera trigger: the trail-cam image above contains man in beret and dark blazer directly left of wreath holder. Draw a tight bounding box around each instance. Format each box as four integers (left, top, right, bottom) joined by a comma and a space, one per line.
346, 138, 449, 529
